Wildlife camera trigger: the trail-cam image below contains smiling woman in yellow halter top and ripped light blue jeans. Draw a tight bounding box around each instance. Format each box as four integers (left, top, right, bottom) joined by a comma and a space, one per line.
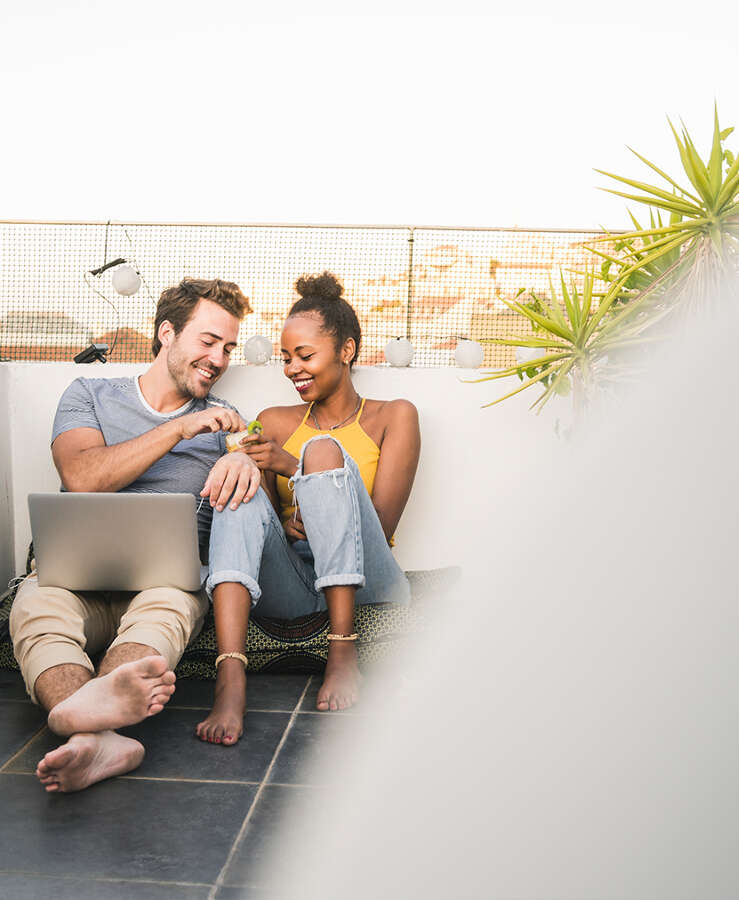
197, 272, 420, 744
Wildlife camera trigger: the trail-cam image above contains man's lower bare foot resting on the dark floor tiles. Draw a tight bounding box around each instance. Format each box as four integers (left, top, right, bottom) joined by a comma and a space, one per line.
36, 731, 144, 793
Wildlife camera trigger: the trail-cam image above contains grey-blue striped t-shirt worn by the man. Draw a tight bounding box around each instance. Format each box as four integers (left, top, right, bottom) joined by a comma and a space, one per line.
51, 378, 243, 560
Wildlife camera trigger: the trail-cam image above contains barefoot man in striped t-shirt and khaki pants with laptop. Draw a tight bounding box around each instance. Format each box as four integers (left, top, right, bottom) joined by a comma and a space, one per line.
10, 279, 260, 791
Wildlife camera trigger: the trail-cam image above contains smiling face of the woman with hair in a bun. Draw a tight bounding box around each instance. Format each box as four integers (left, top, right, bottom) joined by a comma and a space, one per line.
280, 312, 354, 400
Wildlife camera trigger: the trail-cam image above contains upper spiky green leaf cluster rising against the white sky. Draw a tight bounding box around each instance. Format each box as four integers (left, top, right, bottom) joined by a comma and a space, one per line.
596, 107, 739, 304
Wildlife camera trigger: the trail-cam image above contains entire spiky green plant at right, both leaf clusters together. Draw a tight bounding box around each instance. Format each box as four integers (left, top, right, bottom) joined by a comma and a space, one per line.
476, 107, 739, 411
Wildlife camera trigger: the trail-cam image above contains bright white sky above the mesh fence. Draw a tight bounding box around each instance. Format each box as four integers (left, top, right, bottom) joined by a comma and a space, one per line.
0, 0, 739, 227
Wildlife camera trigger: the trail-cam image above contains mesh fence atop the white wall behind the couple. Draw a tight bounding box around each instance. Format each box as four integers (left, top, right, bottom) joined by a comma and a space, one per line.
0, 222, 600, 366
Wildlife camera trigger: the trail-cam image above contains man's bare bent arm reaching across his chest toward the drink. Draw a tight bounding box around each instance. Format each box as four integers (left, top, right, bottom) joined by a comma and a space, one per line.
51, 406, 246, 491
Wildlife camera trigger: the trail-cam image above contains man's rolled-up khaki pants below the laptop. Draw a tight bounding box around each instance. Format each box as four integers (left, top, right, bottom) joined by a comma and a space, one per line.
10, 574, 208, 703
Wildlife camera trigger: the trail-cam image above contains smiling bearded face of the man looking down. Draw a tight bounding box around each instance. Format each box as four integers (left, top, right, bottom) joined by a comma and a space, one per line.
166, 300, 239, 399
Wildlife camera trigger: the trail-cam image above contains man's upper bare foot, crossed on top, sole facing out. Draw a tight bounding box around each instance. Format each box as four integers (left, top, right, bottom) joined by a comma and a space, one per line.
48, 656, 175, 735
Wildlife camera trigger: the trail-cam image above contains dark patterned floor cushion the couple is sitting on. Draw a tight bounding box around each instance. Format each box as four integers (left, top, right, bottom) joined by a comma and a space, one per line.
0, 566, 460, 678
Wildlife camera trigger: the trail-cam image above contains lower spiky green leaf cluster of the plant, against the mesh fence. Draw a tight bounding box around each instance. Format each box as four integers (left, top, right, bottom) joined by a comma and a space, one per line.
475, 272, 657, 412
